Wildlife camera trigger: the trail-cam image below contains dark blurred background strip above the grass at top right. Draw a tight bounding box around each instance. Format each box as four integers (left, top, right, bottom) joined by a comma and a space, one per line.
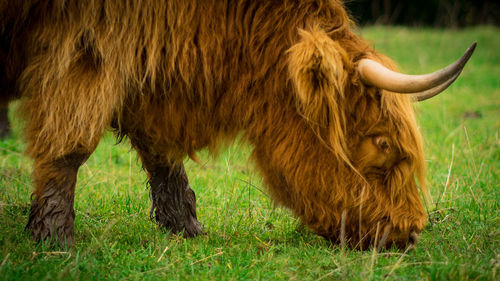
345, 0, 500, 28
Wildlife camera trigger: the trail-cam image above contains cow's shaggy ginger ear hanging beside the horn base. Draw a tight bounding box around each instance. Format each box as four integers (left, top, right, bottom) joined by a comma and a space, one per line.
288, 28, 349, 127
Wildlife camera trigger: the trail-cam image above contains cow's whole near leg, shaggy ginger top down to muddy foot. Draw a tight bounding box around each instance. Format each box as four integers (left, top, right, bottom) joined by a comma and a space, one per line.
19, 45, 120, 246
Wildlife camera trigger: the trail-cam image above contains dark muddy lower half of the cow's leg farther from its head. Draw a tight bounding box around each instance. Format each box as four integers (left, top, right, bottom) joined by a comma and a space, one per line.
26, 152, 90, 247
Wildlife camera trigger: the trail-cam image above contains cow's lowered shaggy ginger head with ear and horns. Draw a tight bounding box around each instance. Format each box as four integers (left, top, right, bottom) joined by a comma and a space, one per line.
257, 25, 475, 249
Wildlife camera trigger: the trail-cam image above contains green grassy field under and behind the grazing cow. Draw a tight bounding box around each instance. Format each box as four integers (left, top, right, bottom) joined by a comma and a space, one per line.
0, 27, 500, 280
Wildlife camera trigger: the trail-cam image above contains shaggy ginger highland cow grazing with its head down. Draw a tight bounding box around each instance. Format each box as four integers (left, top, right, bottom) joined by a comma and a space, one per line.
0, 0, 475, 248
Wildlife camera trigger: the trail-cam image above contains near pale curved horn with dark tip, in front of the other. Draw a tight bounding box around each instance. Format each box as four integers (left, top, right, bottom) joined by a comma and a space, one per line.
358, 42, 477, 95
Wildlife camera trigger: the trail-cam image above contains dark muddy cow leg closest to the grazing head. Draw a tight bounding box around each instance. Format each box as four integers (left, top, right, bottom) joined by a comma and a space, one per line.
132, 140, 203, 237
